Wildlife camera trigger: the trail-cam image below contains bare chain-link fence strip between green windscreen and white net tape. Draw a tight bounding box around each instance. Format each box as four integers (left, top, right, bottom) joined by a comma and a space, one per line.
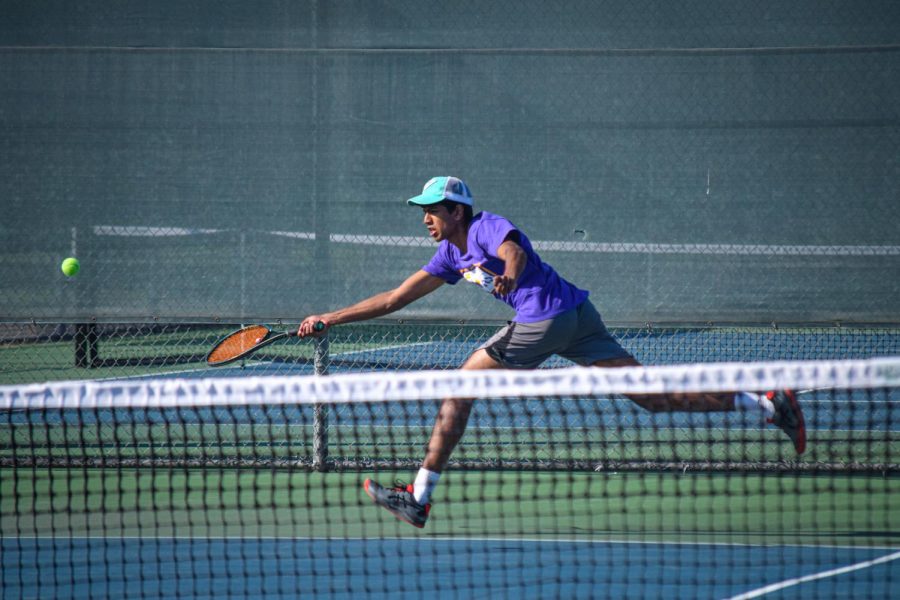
0, 321, 900, 384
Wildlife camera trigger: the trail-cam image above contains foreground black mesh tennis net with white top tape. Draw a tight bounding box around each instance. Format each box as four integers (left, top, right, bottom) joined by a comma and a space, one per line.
0, 358, 900, 598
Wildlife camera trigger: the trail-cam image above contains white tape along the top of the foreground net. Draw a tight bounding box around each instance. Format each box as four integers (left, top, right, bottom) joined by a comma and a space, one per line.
0, 358, 900, 409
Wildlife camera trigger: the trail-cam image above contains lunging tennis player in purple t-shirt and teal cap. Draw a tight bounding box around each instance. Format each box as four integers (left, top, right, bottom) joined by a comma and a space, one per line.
298, 177, 806, 527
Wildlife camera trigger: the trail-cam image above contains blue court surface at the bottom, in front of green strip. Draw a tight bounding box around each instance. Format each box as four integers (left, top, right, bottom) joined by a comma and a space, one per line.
2, 538, 900, 599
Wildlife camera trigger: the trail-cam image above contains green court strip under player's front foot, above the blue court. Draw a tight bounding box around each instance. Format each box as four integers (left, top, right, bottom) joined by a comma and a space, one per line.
0, 468, 900, 547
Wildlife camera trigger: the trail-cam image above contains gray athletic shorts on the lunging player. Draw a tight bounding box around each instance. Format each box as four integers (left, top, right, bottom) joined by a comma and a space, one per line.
479, 300, 631, 369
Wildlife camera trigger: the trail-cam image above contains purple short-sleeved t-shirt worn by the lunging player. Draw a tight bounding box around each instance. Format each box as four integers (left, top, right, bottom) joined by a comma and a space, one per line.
422, 212, 588, 323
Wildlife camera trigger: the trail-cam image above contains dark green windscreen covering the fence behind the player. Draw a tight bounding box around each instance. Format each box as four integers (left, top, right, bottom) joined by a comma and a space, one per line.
0, 0, 900, 323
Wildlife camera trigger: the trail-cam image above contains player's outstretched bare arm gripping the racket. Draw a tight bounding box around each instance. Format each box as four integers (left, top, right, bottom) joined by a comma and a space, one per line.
297, 270, 444, 337
